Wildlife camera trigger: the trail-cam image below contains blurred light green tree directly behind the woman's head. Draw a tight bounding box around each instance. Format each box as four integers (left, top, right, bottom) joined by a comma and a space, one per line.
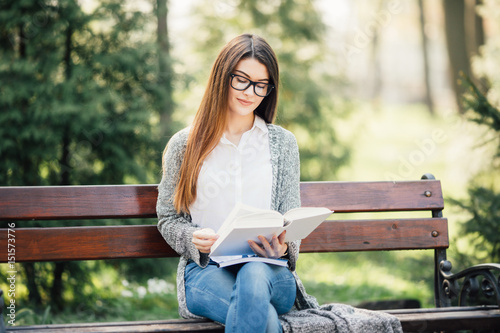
182, 0, 348, 180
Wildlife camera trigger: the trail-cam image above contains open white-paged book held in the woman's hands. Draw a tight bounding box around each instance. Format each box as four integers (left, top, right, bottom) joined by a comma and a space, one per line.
210, 203, 333, 265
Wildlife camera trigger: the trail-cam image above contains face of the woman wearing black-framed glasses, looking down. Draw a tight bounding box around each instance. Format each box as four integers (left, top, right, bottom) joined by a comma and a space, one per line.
228, 58, 269, 117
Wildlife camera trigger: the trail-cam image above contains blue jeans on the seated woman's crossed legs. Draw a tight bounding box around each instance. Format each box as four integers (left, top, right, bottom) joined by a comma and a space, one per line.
184, 261, 297, 333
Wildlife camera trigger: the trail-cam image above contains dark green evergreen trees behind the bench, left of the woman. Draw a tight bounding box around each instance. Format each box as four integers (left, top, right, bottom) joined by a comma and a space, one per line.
0, 0, 179, 309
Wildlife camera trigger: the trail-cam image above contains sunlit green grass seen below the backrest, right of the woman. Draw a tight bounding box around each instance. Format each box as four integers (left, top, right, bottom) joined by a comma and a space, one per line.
297, 251, 433, 307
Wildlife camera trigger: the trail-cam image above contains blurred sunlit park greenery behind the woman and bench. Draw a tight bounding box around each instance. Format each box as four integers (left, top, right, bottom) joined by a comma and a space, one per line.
0, 0, 500, 324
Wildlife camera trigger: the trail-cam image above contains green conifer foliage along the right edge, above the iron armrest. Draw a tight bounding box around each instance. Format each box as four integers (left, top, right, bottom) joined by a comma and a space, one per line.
453, 1, 500, 262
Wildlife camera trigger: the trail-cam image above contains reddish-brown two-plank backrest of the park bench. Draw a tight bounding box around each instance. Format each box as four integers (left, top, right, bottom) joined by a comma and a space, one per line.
0, 176, 448, 262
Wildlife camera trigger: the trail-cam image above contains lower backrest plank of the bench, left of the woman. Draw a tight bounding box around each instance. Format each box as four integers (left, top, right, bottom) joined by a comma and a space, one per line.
0, 225, 178, 262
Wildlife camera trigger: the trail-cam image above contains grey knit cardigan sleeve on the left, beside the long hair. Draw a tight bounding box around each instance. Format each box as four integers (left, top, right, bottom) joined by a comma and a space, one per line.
156, 129, 209, 267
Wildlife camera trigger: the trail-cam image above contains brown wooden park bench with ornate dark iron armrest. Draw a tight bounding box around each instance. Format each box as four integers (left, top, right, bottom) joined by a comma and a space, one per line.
0, 175, 500, 332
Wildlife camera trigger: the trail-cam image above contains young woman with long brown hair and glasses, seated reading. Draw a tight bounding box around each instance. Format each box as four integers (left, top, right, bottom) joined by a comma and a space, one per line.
157, 34, 317, 332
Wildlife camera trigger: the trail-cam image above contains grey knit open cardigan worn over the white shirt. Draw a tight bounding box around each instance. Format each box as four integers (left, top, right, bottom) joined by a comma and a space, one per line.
156, 124, 318, 318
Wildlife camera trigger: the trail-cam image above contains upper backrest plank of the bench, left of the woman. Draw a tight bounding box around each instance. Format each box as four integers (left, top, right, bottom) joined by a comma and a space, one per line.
0, 185, 158, 220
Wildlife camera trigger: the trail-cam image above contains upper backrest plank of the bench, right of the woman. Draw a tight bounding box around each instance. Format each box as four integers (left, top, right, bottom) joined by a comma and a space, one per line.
301, 180, 444, 213
